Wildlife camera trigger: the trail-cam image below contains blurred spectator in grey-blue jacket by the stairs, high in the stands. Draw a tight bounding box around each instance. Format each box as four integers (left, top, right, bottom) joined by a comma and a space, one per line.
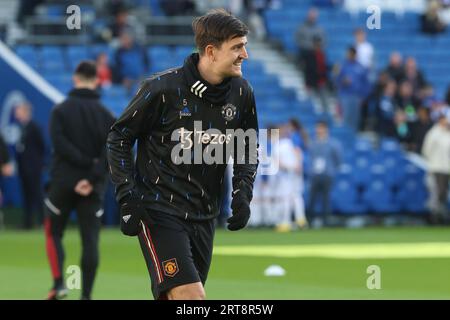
295, 8, 325, 68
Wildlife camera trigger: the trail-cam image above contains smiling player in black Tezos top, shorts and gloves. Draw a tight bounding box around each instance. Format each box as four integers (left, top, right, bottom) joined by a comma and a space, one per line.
107, 10, 258, 300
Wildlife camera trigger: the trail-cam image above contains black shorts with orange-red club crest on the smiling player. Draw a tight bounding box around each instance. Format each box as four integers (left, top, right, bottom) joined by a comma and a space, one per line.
139, 211, 214, 299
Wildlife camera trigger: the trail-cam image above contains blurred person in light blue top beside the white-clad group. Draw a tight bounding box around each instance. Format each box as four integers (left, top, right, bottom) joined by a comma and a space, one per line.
308, 122, 341, 225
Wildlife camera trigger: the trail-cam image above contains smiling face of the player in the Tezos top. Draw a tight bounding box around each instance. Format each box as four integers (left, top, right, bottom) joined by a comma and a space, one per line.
214, 37, 248, 78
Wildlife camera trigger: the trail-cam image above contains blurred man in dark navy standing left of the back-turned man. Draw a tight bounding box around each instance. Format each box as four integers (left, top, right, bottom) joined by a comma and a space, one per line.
14, 102, 45, 229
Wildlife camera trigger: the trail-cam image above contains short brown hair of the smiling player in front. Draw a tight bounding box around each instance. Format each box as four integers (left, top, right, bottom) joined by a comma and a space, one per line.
192, 9, 249, 55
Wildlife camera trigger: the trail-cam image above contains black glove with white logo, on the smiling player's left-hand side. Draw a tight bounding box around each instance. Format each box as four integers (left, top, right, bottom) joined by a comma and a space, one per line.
120, 197, 146, 236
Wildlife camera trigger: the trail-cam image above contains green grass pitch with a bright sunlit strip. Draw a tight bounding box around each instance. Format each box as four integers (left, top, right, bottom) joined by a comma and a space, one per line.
0, 227, 450, 300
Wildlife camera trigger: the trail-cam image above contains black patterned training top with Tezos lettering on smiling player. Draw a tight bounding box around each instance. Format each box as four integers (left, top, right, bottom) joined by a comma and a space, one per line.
107, 54, 258, 221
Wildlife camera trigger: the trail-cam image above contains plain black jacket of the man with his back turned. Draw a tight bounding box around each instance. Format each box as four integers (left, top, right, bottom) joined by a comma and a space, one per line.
50, 89, 115, 193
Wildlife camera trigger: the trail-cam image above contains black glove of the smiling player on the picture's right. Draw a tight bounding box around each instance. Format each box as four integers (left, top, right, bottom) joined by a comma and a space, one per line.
227, 181, 252, 231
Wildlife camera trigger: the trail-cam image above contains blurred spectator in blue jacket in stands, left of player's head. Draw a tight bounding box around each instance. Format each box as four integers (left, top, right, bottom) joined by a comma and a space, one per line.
115, 32, 149, 91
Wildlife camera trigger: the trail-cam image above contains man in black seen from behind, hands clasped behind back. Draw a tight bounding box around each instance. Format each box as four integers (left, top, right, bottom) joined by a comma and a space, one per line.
44, 61, 114, 299
